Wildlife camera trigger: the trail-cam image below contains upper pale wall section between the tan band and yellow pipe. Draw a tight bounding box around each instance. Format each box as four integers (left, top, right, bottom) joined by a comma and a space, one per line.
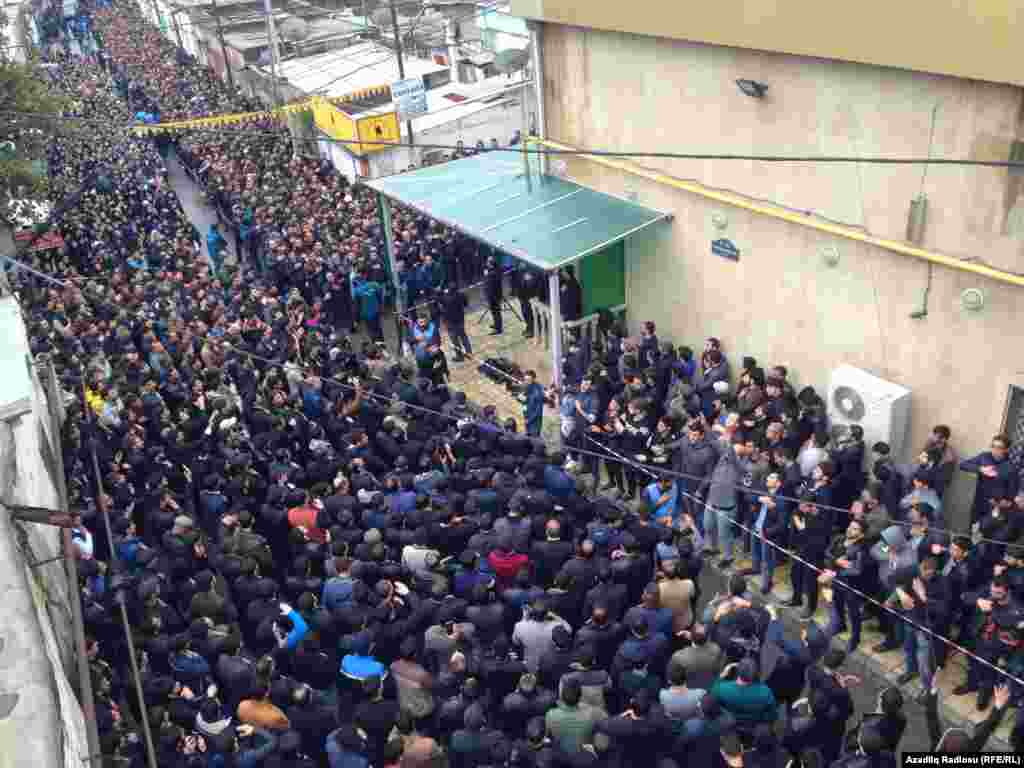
544, 27, 1024, 271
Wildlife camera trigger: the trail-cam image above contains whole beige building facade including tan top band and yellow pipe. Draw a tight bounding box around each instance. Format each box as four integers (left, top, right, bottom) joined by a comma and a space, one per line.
512, 0, 1024, 521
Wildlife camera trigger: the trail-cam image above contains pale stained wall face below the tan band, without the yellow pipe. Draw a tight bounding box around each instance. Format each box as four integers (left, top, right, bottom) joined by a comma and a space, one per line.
544, 26, 1024, 519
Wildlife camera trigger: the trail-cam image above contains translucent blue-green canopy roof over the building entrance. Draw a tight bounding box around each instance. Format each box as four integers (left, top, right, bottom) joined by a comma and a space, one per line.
366, 152, 669, 270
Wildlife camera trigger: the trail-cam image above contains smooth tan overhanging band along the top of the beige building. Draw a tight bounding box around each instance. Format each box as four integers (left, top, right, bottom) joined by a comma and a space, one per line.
512, 0, 1024, 84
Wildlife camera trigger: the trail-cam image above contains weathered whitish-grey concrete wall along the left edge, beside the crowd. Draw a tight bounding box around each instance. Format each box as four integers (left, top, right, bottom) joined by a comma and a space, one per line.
0, 297, 89, 768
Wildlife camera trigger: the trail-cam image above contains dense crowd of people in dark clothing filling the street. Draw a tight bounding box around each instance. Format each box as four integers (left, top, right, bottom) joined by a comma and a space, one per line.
15, 0, 1024, 768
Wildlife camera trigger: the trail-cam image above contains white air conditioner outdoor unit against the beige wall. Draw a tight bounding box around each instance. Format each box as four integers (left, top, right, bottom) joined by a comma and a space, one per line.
828, 366, 910, 461
